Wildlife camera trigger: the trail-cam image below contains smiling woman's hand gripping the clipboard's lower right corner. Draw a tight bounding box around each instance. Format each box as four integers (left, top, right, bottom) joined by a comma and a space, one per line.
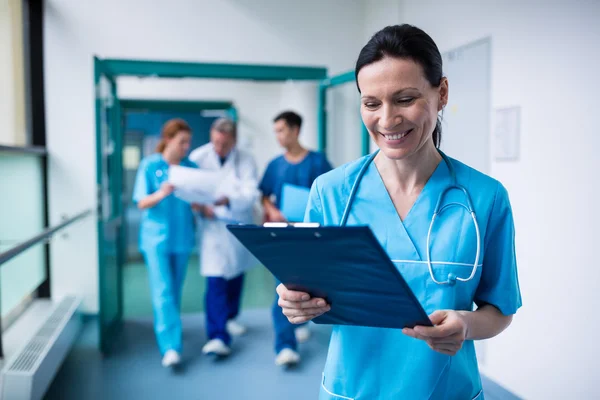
402, 310, 469, 356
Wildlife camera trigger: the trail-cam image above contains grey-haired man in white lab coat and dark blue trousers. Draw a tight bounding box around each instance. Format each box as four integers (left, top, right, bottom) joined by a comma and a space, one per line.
189, 118, 259, 356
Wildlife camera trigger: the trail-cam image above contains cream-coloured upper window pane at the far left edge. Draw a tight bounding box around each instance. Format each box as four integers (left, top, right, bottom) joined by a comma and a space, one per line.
0, 0, 29, 146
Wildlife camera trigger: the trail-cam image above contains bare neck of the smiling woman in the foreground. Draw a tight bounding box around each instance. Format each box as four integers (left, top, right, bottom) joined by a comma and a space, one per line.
375, 142, 442, 194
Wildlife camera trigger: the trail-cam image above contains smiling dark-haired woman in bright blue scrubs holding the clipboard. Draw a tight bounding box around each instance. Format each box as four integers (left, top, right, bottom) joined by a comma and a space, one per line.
277, 25, 521, 400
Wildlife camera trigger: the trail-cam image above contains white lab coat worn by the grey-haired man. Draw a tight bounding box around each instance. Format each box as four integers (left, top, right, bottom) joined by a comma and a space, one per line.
189, 143, 259, 279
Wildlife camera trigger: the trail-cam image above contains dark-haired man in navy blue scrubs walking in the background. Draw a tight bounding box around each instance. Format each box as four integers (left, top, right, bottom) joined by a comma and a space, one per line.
259, 111, 331, 366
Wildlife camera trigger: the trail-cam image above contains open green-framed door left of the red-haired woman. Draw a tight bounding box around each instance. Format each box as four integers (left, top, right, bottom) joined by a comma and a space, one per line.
95, 59, 123, 354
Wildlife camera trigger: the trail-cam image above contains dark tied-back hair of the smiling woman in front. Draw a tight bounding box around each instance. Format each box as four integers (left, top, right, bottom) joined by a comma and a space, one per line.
355, 24, 443, 147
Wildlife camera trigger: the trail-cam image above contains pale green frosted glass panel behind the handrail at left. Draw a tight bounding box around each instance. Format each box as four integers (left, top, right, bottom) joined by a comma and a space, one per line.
0, 152, 46, 317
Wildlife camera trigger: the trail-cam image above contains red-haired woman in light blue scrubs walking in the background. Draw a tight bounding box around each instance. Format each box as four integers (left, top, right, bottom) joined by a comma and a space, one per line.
133, 119, 196, 367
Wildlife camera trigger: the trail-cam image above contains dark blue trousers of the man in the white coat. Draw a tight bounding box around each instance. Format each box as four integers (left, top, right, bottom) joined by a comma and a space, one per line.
204, 274, 244, 346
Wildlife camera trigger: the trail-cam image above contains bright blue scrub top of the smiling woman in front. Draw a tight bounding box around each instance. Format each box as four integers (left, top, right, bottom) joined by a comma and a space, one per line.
305, 157, 521, 400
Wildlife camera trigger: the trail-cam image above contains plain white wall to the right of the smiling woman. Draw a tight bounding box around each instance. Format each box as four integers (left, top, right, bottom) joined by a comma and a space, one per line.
399, 0, 600, 399
